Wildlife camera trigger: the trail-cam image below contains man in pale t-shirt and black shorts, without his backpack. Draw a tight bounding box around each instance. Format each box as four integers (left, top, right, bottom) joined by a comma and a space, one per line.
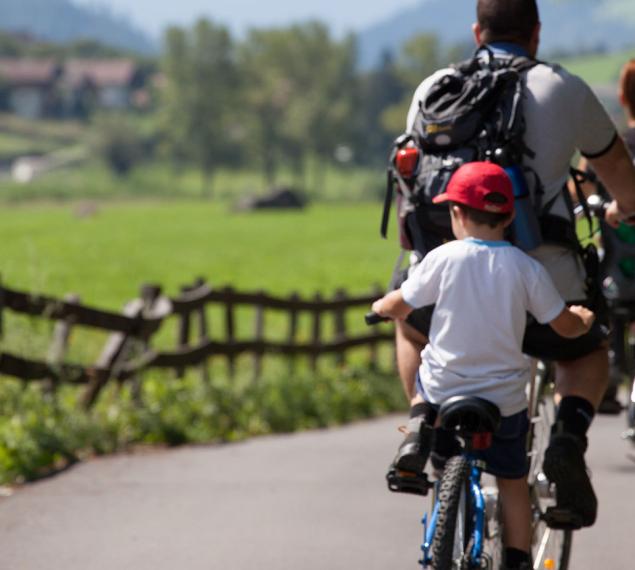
396, 0, 635, 536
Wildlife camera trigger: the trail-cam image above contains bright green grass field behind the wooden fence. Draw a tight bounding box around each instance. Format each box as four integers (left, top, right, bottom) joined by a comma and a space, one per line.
0, 201, 397, 309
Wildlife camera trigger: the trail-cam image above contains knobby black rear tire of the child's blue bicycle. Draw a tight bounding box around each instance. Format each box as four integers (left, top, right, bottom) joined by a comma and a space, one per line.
430, 455, 471, 570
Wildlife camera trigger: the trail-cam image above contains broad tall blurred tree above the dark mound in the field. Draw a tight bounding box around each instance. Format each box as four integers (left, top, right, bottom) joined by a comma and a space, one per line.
240, 22, 355, 189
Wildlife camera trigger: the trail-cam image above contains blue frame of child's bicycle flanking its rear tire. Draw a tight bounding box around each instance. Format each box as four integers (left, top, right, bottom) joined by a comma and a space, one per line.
420, 460, 485, 568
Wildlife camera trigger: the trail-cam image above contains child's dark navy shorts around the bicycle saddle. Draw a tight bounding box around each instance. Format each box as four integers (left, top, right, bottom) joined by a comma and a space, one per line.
434, 410, 529, 479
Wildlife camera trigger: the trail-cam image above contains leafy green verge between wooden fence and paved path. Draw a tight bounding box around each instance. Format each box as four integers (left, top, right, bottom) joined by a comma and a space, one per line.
0, 362, 404, 484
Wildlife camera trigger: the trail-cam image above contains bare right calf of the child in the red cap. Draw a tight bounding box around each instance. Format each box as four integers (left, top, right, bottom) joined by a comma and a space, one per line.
496, 477, 531, 553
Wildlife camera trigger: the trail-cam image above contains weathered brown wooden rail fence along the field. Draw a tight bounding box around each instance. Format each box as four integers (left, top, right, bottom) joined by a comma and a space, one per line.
0, 279, 393, 408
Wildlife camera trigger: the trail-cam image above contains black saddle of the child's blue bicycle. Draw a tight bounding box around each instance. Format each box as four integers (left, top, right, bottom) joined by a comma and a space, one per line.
439, 396, 501, 434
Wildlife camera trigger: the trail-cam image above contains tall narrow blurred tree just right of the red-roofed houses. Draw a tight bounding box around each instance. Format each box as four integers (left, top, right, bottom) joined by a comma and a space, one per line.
162, 19, 238, 194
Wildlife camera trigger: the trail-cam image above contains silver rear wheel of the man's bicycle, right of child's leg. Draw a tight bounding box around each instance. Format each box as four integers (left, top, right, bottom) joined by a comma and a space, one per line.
528, 362, 572, 570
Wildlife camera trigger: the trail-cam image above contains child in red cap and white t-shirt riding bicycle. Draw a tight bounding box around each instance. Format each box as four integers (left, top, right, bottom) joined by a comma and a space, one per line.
373, 162, 594, 569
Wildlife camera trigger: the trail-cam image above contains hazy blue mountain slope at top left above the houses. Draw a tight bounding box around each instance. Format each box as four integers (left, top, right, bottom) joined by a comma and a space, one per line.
0, 0, 158, 54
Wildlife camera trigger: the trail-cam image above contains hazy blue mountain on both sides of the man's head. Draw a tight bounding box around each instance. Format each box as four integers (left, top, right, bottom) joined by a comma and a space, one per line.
357, 0, 635, 69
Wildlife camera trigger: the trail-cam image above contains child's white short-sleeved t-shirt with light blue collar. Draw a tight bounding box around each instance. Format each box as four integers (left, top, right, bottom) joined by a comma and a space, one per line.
401, 238, 565, 416
